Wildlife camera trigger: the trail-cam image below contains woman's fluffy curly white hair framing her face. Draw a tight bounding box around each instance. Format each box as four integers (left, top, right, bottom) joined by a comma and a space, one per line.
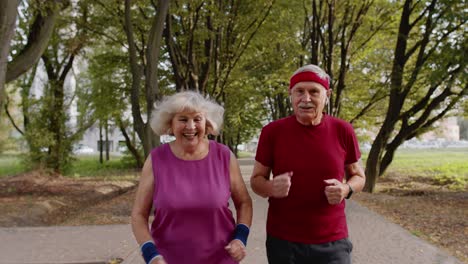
151, 91, 224, 136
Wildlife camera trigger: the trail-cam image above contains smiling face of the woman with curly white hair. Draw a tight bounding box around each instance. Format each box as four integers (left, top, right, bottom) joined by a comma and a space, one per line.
171, 111, 206, 147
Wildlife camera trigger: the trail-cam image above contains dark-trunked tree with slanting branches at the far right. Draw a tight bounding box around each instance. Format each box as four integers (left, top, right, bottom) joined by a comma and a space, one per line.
365, 0, 468, 192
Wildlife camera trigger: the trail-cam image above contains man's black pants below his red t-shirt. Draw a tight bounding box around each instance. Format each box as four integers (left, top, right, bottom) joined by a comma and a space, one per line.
266, 236, 353, 264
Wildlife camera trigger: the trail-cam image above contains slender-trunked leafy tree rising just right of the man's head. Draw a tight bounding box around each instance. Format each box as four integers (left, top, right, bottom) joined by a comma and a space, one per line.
300, 0, 390, 116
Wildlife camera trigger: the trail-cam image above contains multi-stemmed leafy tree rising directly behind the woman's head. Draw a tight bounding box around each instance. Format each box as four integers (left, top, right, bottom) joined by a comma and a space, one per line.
164, 0, 274, 154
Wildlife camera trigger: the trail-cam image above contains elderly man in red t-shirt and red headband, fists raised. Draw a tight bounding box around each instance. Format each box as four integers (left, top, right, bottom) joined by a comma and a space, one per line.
251, 65, 365, 264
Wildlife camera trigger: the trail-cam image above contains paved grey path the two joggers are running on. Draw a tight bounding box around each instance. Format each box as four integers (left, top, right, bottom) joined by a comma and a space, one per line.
0, 161, 461, 264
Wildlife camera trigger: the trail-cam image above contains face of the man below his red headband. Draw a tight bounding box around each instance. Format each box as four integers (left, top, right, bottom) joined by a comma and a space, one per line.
290, 82, 330, 125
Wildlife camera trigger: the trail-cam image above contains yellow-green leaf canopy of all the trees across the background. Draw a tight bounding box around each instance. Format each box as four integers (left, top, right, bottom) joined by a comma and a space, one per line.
0, 0, 468, 179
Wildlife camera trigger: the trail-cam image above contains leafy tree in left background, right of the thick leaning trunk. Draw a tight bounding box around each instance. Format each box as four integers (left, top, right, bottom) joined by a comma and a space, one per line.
14, 2, 93, 173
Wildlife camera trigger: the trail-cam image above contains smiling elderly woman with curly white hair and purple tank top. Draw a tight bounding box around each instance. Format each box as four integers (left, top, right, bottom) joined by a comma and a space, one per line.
132, 92, 252, 264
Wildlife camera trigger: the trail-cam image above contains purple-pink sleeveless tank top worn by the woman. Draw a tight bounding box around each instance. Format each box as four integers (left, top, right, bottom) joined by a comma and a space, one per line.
151, 140, 237, 264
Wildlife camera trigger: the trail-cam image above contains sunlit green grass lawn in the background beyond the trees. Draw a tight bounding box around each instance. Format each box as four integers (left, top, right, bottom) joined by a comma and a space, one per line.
0, 148, 468, 182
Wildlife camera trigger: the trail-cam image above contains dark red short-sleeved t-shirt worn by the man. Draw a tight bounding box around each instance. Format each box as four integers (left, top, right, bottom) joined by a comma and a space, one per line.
255, 114, 361, 244
